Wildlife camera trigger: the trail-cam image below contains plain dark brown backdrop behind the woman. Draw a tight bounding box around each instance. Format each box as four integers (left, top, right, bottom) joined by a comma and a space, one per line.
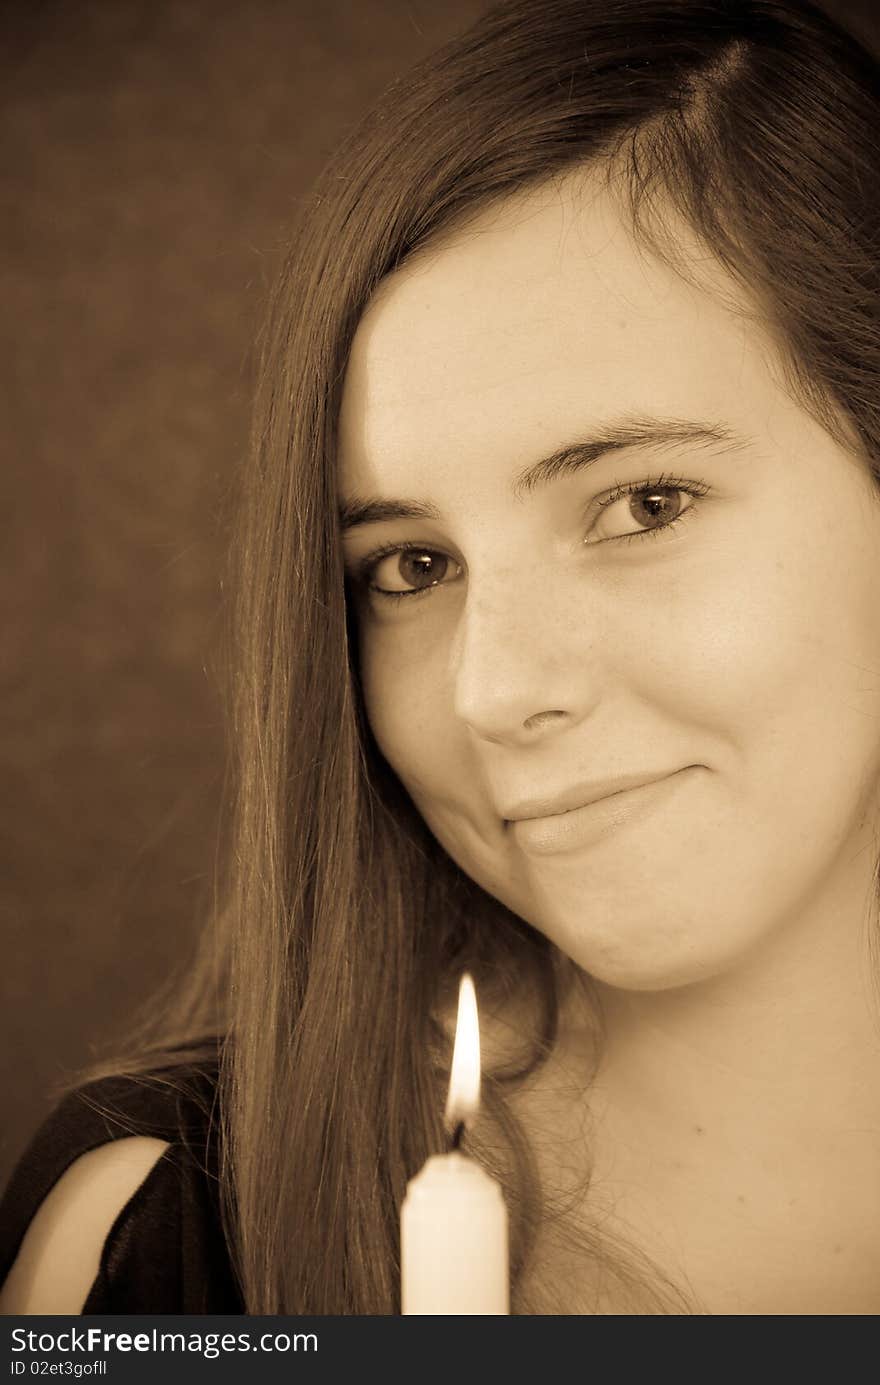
0, 0, 879, 1183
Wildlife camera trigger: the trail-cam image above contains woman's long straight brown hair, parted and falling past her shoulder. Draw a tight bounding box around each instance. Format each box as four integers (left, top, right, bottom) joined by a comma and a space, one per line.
67, 0, 880, 1314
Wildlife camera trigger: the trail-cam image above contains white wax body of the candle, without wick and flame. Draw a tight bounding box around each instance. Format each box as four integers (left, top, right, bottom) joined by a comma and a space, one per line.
401, 1151, 510, 1314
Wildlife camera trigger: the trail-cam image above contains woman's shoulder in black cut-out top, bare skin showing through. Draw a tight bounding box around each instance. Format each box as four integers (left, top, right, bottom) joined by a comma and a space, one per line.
0, 1043, 241, 1313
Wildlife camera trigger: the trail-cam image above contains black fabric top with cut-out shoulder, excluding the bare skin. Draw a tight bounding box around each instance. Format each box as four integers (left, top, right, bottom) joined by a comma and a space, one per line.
0, 1062, 244, 1313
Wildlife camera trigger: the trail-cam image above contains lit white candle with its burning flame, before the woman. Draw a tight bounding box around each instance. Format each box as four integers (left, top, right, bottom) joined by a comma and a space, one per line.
401, 972, 510, 1314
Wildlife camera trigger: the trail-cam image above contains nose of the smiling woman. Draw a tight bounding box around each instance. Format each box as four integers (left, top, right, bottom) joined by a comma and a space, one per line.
452, 571, 600, 745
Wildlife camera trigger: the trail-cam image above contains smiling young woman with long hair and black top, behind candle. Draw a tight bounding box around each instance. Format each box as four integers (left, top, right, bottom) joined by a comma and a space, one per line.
3, 0, 880, 1314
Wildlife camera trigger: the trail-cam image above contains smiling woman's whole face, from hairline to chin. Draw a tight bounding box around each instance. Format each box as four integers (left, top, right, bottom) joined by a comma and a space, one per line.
340, 181, 880, 989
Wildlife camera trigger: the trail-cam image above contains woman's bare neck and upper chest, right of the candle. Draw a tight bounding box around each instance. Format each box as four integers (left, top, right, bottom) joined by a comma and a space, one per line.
545, 864, 880, 1313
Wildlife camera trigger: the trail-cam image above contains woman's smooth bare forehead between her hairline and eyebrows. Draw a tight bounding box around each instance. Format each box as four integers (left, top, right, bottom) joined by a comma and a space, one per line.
341, 174, 766, 488
